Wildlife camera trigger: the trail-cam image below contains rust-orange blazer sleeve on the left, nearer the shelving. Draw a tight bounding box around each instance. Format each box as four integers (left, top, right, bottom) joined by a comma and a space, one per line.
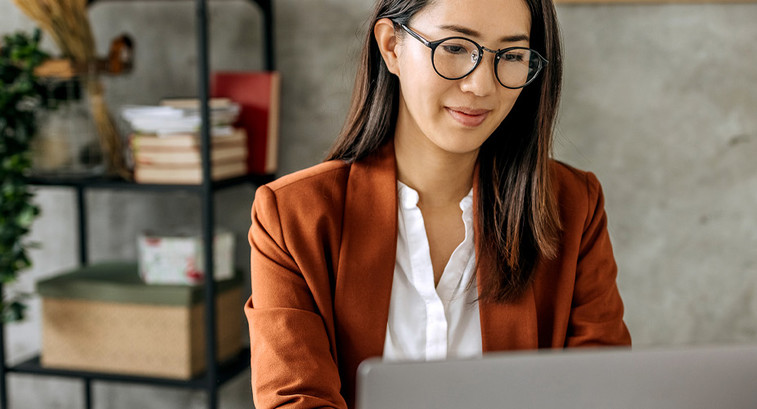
245, 186, 347, 409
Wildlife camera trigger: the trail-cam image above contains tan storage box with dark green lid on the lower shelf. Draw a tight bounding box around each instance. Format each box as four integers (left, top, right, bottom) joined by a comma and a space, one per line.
38, 264, 242, 379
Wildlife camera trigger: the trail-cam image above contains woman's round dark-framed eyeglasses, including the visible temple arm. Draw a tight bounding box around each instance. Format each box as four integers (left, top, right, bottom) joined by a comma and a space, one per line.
395, 22, 549, 89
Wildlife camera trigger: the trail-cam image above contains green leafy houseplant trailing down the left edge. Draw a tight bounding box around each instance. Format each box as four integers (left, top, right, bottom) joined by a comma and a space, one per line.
0, 30, 47, 322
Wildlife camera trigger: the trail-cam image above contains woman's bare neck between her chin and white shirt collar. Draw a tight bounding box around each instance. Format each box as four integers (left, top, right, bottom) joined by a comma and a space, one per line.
394, 134, 478, 208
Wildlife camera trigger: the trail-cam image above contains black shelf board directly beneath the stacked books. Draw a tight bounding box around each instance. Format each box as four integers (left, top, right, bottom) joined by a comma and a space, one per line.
27, 174, 275, 192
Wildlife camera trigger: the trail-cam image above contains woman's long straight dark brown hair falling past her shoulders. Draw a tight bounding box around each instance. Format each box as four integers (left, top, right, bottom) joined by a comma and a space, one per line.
326, 0, 562, 302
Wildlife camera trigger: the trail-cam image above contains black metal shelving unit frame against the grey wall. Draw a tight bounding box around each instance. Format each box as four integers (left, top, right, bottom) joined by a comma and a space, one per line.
0, 0, 275, 409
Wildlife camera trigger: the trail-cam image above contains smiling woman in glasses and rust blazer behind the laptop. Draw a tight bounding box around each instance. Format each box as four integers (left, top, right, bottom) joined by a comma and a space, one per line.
245, 0, 630, 408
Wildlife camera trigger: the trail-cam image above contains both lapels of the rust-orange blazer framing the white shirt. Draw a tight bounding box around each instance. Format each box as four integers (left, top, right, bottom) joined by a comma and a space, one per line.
334, 142, 538, 360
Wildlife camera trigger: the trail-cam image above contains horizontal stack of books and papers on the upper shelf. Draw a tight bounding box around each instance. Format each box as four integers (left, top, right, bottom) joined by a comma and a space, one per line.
122, 99, 249, 184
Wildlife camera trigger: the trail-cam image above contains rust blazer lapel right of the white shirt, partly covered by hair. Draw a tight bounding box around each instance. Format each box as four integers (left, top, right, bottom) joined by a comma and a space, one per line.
473, 169, 539, 352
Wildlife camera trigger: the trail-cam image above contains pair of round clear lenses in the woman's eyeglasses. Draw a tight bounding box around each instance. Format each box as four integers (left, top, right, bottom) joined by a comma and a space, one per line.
433, 38, 541, 88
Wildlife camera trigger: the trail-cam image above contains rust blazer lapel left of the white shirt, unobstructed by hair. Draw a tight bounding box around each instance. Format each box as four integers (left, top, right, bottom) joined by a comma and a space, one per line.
334, 142, 397, 360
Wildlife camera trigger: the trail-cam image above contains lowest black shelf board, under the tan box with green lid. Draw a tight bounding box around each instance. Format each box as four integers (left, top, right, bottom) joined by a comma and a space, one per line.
7, 348, 250, 389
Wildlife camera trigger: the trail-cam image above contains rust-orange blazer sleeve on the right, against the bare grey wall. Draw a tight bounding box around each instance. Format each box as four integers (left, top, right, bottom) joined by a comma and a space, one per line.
566, 173, 631, 347
